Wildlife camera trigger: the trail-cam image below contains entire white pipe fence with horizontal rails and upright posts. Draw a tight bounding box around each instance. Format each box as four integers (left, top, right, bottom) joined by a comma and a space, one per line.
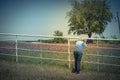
0, 33, 120, 71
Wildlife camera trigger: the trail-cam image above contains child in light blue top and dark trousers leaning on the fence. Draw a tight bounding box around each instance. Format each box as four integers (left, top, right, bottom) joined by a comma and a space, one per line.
72, 37, 87, 74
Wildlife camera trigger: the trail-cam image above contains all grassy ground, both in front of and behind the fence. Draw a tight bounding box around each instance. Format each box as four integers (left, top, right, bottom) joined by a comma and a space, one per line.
0, 43, 120, 80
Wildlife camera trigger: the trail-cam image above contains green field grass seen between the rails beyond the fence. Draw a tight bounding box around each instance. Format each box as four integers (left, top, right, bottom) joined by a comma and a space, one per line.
0, 48, 120, 73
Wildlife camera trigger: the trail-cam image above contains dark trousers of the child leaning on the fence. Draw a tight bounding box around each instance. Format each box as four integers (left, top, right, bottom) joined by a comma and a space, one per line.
74, 51, 82, 73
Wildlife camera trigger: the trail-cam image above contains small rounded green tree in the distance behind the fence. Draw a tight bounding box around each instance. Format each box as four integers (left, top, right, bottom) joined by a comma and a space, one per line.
53, 30, 67, 43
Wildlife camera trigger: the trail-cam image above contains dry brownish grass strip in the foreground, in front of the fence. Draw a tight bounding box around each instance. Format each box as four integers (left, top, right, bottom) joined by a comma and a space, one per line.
0, 60, 120, 80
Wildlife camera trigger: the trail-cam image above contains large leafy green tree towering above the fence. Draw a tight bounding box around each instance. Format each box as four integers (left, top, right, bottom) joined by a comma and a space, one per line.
67, 0, 113, 38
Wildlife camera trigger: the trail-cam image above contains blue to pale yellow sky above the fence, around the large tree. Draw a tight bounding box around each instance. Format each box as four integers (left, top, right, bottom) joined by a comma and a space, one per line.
0, 0, 120, 38
